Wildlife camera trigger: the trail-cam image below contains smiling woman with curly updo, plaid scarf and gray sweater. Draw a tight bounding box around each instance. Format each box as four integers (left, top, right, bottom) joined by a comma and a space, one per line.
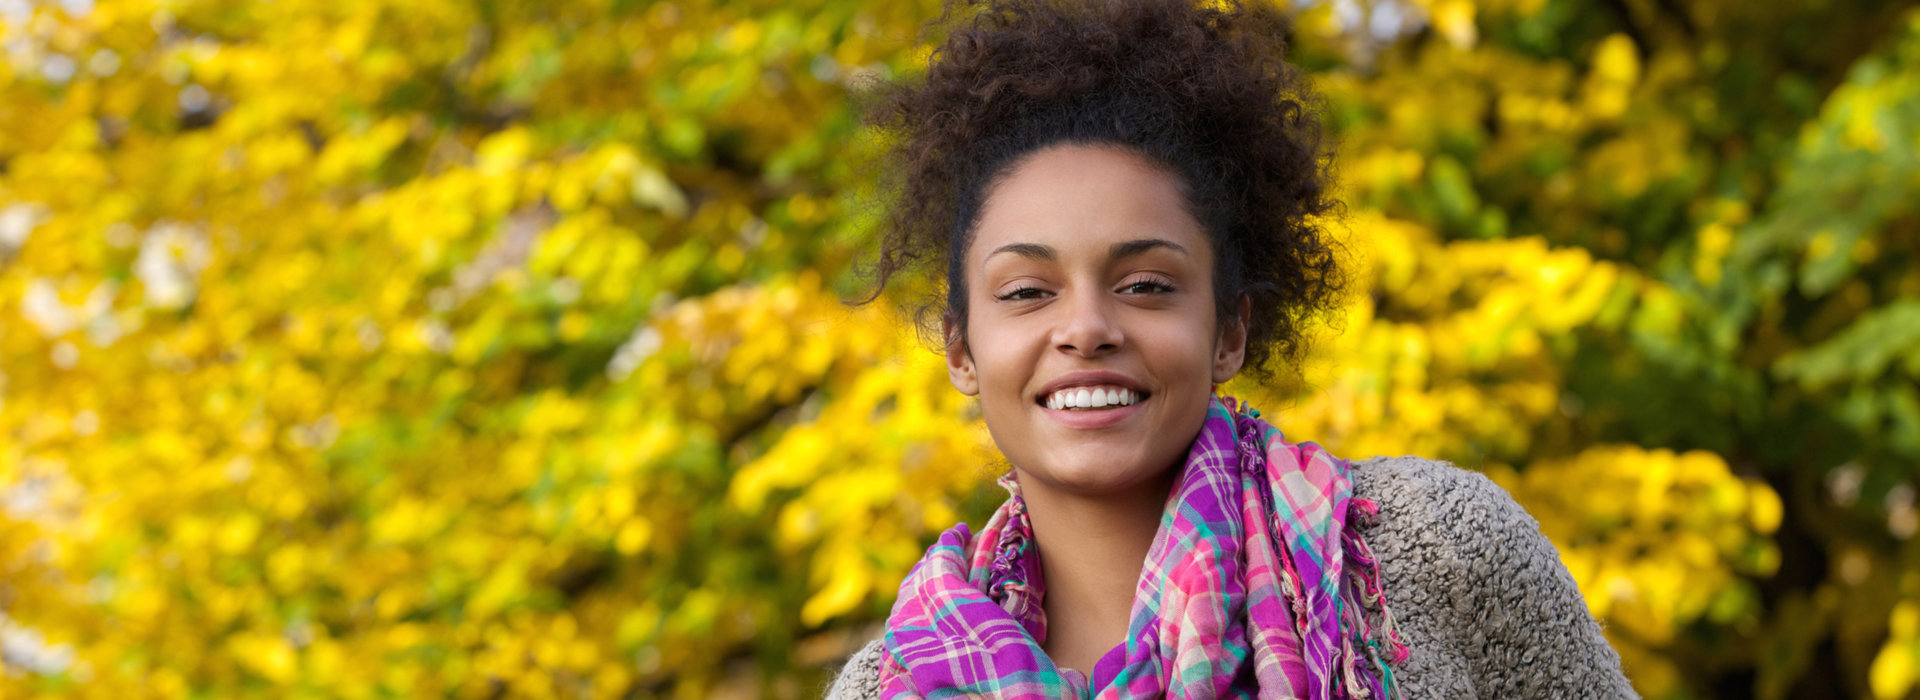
829, 0, 1632, 698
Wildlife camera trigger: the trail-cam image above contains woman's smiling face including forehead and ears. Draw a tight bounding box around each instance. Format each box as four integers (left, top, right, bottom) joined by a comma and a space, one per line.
947, 146, 1246, 495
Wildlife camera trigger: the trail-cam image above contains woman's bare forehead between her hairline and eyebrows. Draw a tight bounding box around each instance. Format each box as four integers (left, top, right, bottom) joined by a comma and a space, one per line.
968, 144, 1210, 263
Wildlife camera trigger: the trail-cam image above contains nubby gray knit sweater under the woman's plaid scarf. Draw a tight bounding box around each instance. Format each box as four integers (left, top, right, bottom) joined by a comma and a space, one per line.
828, 456, 1634, 700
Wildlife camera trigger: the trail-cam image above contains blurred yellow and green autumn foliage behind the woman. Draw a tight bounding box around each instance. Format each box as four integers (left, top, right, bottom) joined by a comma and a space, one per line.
0, 0, 1920, 698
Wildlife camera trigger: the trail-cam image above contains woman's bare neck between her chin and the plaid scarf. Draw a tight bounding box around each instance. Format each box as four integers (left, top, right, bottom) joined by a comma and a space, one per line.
1021, 468, 1179, 677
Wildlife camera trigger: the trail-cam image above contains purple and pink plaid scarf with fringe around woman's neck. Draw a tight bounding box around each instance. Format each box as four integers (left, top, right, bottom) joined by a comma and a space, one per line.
879, 397, 1407, 700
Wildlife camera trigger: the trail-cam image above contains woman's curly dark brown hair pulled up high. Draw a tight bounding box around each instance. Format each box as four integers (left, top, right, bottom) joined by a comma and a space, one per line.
862, 0, 1346, 378
